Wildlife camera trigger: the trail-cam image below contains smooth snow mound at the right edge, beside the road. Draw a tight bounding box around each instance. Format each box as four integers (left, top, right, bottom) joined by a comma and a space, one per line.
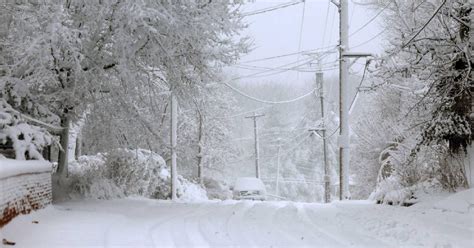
434, 189, 474, 213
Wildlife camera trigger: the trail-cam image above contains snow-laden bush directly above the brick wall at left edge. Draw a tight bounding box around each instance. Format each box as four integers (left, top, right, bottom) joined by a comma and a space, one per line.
0, 99, 53, 160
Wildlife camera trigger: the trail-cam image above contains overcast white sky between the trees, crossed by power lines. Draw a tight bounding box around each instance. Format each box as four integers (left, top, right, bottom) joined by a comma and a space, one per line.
231, 0, 381, 82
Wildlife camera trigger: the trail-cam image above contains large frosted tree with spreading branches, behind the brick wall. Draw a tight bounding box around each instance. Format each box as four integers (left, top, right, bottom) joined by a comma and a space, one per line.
2, 0, 246, 178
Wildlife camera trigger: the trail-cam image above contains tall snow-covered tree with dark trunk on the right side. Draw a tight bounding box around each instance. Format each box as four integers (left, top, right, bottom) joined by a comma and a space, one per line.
356, 0, 473, 199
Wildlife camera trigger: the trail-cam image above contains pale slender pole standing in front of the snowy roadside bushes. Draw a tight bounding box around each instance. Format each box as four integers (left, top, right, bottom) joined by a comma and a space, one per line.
170, 88, 178, 200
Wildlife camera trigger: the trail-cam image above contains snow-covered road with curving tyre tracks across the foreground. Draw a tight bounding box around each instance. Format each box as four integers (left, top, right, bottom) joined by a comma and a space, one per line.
1, 199, 474, 247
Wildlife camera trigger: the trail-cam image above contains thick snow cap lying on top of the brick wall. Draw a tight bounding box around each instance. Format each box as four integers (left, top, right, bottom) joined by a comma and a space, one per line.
0, 159, 51, 179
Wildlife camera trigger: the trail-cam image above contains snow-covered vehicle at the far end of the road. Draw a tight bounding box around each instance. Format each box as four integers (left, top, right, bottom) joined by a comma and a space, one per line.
233, 177, 267, 201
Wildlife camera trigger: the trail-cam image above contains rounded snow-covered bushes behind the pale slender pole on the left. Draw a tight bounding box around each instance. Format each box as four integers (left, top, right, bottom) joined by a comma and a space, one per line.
67, 149, 207, 201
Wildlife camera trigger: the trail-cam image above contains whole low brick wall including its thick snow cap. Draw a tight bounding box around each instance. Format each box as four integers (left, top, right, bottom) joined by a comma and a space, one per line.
0, 159, 52, 227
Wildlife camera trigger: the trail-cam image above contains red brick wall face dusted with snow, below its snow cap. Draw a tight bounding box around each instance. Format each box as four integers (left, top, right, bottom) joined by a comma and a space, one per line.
0, 164, 52, 227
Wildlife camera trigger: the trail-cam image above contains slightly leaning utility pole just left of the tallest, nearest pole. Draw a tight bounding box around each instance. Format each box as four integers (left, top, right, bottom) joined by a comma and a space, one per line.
316, 66, 331, 203
